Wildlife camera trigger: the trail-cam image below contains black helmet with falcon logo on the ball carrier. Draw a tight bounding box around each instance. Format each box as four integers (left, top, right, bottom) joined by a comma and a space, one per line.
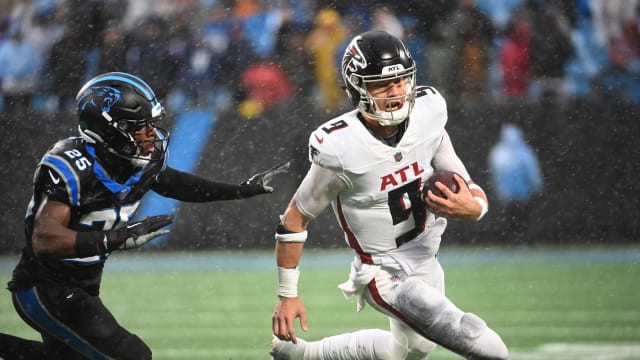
342, 31, 416, 126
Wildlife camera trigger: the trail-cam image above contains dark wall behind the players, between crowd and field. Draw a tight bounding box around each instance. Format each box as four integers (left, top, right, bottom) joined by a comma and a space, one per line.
0, 98, 640, 253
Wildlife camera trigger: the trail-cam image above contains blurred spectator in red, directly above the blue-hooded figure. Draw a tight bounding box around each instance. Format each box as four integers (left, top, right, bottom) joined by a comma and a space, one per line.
500, 20, 531, 98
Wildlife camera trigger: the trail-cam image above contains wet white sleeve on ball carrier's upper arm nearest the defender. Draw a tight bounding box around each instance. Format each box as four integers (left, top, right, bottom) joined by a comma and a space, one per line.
295, 163, 348, 218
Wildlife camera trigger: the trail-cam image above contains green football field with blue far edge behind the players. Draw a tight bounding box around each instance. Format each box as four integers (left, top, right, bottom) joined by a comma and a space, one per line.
0, 246, 640, 360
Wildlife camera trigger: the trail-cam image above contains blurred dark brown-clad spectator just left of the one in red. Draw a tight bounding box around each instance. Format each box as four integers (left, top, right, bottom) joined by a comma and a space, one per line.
451, 0, 495, 99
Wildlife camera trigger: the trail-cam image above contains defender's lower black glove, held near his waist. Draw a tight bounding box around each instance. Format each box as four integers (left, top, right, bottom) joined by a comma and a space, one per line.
104, 215, 175, 252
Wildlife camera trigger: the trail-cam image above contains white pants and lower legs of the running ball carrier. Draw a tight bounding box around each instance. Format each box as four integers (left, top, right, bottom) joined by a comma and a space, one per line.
304, 257, 508, 360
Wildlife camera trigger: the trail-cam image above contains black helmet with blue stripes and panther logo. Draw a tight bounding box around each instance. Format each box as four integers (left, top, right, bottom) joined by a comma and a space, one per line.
76, 72, 169, 166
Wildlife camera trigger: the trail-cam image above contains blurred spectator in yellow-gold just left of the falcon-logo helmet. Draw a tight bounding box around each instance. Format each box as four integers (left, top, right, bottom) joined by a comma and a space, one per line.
305, 8, 349, 111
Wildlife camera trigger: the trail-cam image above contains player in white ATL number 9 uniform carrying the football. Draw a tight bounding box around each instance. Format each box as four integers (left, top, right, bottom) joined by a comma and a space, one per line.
271, 31, 508, 360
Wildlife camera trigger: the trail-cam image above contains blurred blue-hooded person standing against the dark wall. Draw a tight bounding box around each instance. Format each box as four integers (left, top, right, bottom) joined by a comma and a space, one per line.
488, 124, 543, 243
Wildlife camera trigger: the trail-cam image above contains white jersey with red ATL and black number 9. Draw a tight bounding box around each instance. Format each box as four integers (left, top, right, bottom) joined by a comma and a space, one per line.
298, 87, 468, 257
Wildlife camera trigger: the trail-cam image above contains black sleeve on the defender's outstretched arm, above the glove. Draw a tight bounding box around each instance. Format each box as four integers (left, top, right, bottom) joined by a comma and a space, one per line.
151, 167, 239, 202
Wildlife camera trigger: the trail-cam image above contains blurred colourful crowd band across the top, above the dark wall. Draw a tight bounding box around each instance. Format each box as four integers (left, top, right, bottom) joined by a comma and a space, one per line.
0, 0, 640, 117
